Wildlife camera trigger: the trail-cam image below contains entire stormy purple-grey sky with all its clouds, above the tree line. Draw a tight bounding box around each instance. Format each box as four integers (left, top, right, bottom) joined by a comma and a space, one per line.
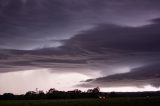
0, 0, 160, 93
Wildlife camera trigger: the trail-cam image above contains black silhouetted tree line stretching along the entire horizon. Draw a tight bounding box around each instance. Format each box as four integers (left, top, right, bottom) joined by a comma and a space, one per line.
0, 87, 160, 100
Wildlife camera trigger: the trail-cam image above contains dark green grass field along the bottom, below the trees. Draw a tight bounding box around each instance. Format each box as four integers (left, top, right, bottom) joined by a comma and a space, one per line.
0, 97, 160, 106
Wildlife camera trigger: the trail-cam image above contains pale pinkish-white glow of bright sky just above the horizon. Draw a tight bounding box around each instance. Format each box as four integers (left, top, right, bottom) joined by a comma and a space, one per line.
0, 69, 160, 94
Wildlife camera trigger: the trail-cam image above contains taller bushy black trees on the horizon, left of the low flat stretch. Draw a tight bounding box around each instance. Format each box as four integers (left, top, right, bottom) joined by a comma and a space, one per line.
0, 87, 100, 100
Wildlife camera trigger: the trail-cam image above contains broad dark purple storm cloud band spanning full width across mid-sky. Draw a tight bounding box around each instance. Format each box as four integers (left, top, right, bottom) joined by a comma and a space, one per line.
0, 19, 160, 75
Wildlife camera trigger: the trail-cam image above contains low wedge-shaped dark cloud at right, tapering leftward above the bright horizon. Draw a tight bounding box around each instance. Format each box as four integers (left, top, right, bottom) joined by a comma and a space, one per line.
79, 63, 160, 87
